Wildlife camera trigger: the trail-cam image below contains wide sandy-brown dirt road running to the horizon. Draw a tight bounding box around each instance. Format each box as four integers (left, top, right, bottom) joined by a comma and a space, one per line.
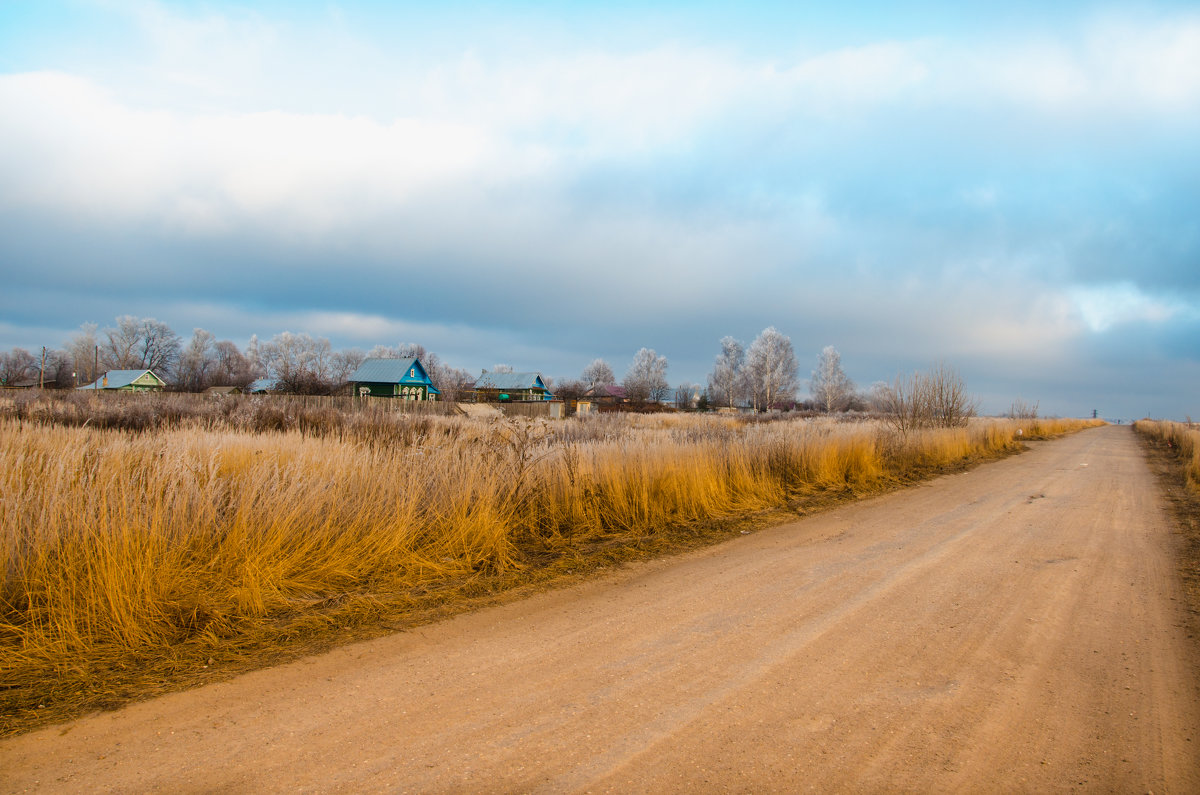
0, 428, 1200, 793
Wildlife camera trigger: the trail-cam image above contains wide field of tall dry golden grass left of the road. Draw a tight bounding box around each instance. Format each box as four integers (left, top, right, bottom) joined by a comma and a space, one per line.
0, 416, 1104, 731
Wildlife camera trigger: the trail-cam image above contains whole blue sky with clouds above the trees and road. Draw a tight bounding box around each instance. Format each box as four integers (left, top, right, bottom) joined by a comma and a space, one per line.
0, 0, 1200, 419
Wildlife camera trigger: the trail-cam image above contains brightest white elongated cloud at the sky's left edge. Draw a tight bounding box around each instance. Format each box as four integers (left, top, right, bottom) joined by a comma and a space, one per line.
0, 72, 499, 232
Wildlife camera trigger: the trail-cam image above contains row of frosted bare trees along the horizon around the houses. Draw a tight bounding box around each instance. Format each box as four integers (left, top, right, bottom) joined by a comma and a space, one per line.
0, 315, 974, 430
